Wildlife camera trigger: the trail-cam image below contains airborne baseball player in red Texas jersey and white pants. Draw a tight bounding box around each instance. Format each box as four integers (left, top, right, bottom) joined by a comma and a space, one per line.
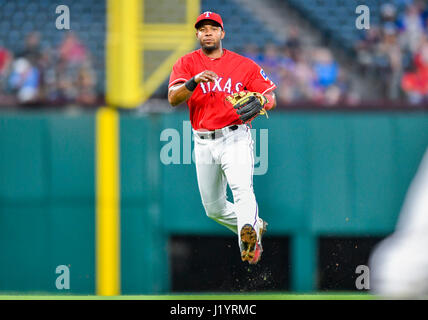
168, 11, 276, 264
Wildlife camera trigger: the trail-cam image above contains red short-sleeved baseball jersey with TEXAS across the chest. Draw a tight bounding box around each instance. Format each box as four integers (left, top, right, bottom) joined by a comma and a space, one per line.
168, 49, 276, 130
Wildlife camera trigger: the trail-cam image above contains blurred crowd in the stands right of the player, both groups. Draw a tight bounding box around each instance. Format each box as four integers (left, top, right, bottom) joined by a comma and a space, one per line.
243, 0, 428, 106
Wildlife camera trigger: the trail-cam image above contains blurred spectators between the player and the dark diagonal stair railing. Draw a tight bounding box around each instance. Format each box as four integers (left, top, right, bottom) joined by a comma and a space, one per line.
243, 27, 357, 106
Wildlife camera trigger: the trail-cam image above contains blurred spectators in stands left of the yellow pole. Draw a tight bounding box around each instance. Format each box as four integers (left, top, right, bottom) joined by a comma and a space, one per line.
0, 32, 97, 106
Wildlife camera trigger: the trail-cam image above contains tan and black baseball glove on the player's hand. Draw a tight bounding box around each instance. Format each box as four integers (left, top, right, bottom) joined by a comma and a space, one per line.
226, 91, 267, 123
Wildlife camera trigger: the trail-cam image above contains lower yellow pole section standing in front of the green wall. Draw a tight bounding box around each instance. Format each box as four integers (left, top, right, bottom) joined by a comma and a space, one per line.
96, 107, 120, 296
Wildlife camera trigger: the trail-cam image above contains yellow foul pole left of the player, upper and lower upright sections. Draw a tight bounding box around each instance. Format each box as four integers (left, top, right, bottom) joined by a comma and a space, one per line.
96, 0, 142, 296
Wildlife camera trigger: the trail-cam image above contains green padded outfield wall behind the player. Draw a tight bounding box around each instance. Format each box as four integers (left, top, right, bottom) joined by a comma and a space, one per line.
0, 111, 428, 294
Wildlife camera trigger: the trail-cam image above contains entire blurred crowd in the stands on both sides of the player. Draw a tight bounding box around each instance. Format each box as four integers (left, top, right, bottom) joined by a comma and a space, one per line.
0, 0, 428, 106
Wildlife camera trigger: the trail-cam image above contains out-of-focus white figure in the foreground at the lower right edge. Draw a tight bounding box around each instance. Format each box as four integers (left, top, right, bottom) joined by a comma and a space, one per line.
369, 149, 428, 299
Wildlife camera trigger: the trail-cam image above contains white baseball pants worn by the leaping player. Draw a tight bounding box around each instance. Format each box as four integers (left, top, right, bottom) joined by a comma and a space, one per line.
193, 125, 261, 243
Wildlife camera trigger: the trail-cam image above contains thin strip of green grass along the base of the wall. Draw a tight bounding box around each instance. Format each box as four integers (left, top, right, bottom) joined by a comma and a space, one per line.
0, 292, 377, 300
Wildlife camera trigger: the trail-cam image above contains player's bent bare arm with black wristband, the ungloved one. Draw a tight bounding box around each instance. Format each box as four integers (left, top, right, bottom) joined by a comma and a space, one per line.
168, 70, 217, 107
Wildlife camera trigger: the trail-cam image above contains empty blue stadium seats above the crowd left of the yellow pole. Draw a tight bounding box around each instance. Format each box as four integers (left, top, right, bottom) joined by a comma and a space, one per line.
0, 0, 106, 91
